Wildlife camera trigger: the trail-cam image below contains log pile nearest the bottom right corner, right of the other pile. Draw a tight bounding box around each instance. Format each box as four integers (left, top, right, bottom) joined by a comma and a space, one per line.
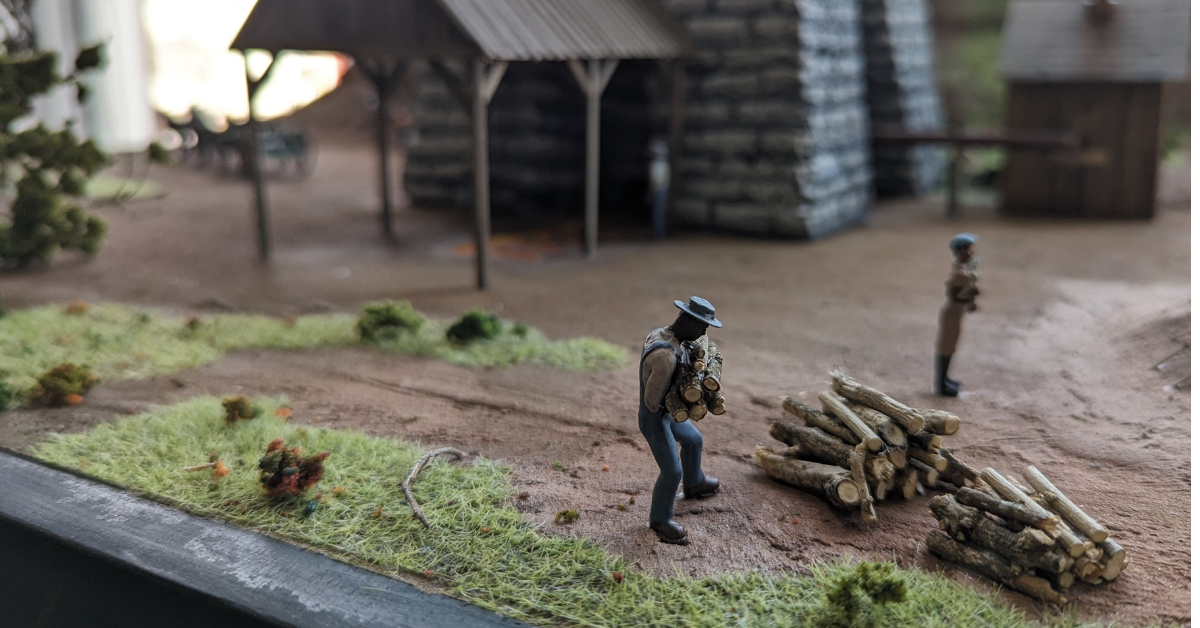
925, 466, 1129, 604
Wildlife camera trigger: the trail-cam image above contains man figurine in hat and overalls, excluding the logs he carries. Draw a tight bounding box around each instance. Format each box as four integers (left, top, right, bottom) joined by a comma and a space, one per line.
637, 297, 721, 545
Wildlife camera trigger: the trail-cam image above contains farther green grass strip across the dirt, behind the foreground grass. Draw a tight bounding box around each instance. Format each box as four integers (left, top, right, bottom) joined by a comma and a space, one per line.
0, 304, 628, 389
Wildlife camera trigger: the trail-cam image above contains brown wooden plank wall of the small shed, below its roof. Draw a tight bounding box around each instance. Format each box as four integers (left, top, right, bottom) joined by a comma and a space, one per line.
1001, 82, 1162, 219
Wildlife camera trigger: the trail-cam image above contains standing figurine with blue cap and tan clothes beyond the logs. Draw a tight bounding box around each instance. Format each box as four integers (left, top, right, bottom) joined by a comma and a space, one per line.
934, 233, 979, 397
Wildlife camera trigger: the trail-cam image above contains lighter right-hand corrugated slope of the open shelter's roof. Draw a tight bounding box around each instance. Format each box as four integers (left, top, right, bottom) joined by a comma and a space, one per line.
438, 0, 688, 61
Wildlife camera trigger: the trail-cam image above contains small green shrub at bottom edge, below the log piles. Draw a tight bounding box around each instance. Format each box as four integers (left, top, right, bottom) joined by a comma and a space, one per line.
821, 562, 908, 628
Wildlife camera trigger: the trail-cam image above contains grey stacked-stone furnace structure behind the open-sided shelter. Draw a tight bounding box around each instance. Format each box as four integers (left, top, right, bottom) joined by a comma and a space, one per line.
406, 0, 941, 238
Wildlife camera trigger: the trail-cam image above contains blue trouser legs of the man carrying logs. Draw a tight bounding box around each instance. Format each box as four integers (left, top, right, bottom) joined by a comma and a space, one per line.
637, 413, 704, 524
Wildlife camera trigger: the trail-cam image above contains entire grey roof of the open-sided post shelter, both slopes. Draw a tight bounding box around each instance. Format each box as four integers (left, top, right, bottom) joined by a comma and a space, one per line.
230, 0, 689, 61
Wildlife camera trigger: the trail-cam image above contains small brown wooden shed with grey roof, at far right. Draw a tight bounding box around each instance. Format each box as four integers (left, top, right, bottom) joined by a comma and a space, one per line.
1000, 0, 1189, 219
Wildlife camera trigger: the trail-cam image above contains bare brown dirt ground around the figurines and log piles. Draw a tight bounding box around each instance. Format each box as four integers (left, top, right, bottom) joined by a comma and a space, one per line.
0, 140, 1192, 623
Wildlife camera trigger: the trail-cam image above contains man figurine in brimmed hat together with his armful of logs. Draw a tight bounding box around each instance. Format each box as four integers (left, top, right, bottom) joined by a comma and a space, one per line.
637, 297, 725, 545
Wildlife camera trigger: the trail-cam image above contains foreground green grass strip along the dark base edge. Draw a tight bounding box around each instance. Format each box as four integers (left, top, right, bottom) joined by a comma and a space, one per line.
25, 397, 1142, 628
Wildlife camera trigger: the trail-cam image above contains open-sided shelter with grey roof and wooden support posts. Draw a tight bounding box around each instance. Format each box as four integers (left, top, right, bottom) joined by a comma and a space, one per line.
229, 0, 691, 289
